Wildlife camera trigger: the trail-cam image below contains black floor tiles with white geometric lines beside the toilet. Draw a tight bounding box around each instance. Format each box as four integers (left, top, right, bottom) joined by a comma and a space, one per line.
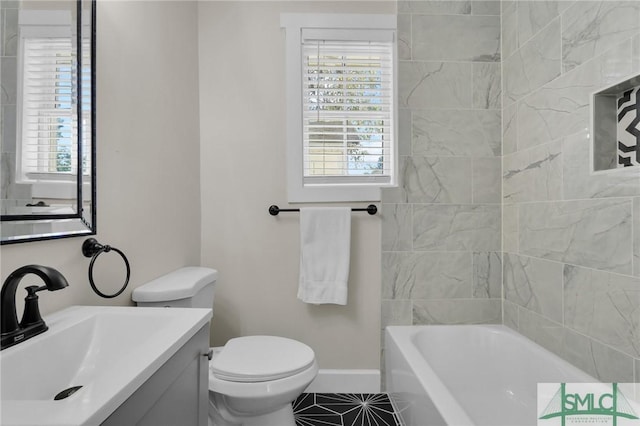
293, 393, 402, 426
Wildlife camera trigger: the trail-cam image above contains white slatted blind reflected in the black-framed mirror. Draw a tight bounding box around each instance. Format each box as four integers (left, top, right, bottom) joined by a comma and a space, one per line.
21, 37, 78, 180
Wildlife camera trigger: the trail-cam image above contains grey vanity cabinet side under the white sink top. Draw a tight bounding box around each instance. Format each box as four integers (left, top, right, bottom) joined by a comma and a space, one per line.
102, 324, 209, 426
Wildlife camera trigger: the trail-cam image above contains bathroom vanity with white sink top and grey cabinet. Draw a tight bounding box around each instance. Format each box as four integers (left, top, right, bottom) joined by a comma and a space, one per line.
0, 306, 211, 426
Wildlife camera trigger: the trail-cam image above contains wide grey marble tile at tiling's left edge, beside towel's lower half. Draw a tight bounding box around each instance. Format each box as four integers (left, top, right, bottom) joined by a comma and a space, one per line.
382, 252, 473, 300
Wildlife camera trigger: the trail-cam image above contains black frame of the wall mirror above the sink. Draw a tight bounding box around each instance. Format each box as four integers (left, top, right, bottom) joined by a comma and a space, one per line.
0, 0, 97, 245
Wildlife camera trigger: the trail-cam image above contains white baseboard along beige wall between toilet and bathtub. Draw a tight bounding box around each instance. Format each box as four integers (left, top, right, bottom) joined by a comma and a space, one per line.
305, 369, 380, 393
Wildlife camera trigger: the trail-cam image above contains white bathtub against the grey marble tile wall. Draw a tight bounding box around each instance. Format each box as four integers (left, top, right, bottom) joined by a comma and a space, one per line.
385, 325, 598, 426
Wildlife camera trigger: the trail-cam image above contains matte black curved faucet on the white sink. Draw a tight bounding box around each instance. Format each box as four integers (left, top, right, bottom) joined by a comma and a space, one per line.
0, 265, 69, 350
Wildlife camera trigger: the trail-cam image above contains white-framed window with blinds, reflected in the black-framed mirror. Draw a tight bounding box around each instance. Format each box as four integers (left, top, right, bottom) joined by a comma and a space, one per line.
16, 10, 89, 184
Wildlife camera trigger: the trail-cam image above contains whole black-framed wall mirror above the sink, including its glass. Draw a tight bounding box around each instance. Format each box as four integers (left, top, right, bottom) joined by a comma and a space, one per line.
0, 0, 96, 244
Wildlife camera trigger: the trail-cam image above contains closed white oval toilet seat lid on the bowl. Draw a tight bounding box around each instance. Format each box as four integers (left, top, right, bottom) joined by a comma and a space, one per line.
209, 336, 315, 383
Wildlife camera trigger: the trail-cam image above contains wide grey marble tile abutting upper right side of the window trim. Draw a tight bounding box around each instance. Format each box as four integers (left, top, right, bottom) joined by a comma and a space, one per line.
398, 61, 473, 109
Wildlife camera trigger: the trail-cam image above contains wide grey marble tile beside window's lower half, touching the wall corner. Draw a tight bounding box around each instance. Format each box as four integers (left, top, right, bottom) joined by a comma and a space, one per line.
412, 109, 501, 157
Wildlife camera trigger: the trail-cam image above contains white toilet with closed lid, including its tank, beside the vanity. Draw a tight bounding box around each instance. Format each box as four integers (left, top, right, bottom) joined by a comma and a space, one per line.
131, 267, 318, 426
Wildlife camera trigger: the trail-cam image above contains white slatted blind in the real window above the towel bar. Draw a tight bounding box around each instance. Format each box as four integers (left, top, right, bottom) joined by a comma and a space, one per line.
302, 32, 394, 184
